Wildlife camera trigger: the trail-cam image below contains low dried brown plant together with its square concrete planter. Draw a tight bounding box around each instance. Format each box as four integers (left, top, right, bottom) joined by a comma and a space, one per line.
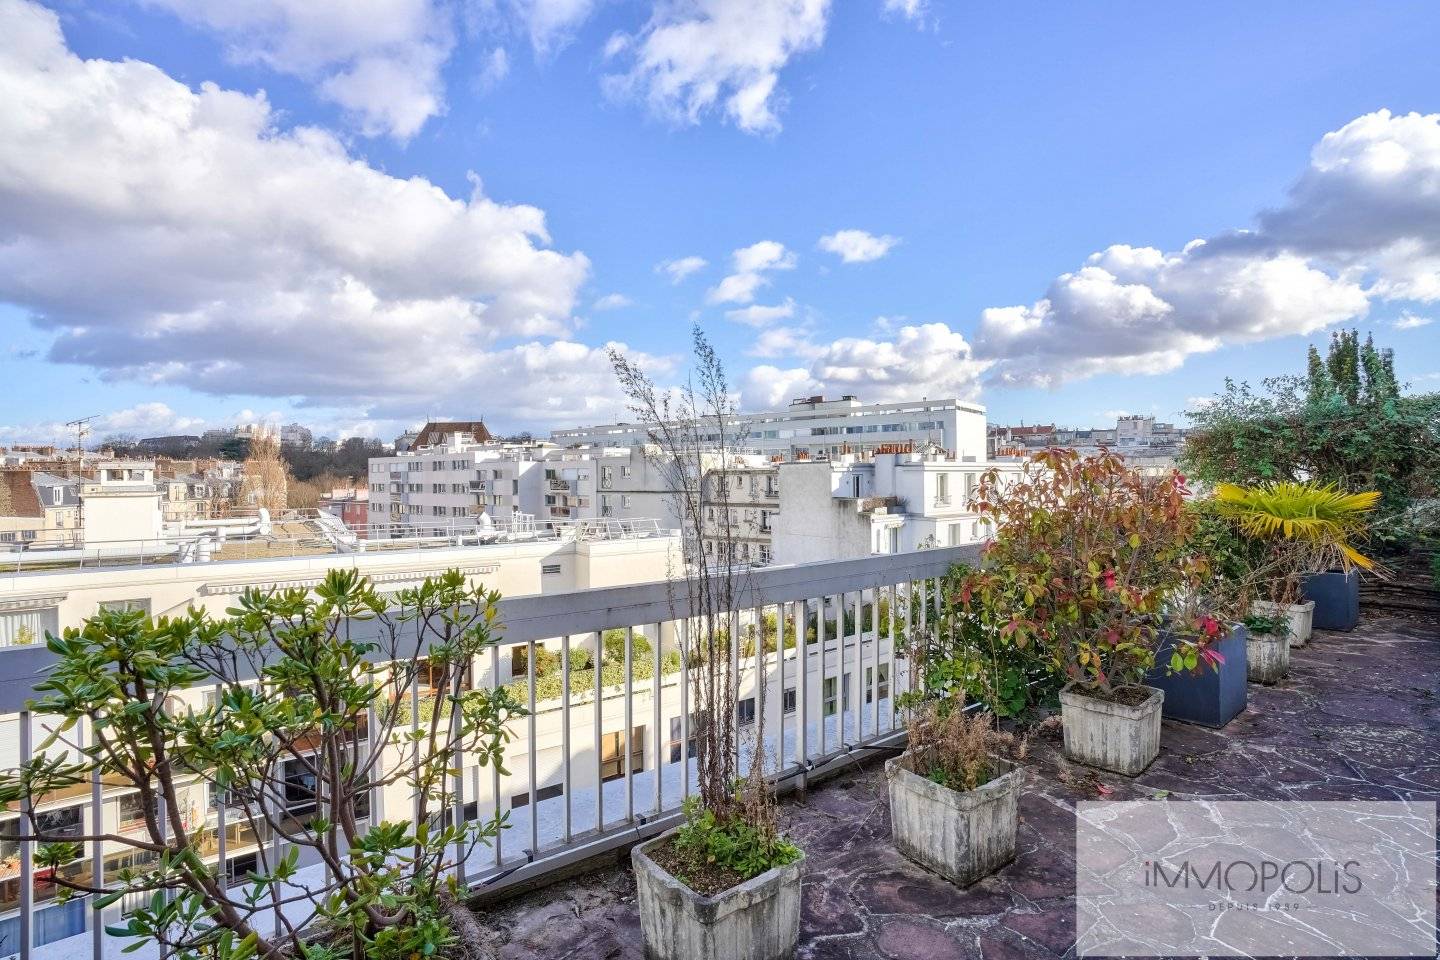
886, 697, 1025, 887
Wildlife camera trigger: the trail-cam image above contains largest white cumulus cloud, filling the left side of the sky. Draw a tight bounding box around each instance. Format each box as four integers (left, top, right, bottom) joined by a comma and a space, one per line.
0, 0, 619, 428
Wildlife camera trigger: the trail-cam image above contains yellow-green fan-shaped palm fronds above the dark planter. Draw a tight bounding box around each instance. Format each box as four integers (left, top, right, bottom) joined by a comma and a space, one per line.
1215, 481, 1380, 579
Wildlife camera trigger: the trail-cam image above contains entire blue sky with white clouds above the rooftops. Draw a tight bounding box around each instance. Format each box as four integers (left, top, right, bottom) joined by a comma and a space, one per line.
0, 0, 1440, 442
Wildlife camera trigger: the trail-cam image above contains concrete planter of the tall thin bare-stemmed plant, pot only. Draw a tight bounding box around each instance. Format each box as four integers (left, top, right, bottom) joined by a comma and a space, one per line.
631, 830, 805, 960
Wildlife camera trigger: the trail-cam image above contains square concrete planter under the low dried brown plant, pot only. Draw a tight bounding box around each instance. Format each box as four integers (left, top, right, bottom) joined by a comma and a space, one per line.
886, 753, 1022, 887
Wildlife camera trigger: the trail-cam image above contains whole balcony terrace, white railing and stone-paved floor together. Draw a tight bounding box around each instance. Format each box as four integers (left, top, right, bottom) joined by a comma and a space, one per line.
0, 547, 1440, 960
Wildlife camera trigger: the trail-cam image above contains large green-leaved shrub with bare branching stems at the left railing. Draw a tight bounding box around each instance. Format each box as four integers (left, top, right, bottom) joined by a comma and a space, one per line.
0, 570, 523, 960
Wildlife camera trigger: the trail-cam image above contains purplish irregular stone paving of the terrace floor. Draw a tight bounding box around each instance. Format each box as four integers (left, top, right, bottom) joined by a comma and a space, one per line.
485, 617, 1440, 960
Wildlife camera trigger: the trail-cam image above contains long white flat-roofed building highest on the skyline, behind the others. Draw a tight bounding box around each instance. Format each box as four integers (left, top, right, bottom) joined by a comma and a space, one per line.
550, 396, 985, 459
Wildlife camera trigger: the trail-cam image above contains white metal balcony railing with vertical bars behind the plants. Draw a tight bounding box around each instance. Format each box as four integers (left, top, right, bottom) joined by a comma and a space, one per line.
0, 547, 978, 960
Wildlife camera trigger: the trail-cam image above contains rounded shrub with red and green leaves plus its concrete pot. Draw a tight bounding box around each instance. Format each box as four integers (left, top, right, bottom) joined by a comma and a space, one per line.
968, 449, 1214, 776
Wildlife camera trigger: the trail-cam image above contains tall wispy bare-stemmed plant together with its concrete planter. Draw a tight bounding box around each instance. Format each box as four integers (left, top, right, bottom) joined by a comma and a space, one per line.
611, 327, 804, 960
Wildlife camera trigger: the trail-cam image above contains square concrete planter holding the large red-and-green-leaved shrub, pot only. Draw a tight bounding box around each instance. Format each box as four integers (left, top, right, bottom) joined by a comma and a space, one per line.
1060, 682, 1165, 777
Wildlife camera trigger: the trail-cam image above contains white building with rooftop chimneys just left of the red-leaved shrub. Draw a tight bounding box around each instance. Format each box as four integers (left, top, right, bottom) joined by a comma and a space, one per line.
770, 449, 1021, 564
